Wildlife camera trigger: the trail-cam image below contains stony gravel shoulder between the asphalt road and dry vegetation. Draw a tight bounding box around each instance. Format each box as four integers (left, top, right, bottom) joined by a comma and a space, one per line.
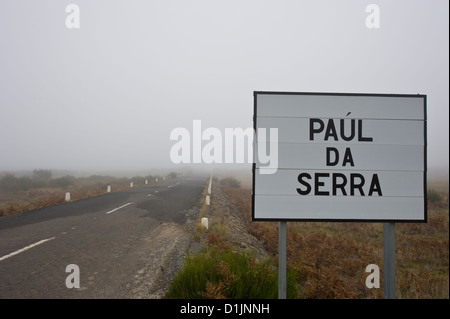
129, 183, 268, 299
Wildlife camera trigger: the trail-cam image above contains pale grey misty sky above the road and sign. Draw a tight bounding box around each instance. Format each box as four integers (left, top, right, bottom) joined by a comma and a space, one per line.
0, 0, 449, 171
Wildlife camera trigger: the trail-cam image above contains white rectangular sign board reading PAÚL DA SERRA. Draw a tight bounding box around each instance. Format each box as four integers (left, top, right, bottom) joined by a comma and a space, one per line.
253, 92, 426, 222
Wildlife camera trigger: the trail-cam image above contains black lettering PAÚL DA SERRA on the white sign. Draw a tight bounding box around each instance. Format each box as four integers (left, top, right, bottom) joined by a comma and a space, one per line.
297, 118, 383, 196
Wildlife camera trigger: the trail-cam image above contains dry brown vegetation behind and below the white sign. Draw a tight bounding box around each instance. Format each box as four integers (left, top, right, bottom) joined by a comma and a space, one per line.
225, 176, 449, 298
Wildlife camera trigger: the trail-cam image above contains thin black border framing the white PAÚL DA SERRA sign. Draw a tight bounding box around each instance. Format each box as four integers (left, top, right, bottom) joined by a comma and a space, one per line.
252, 91, 428, 223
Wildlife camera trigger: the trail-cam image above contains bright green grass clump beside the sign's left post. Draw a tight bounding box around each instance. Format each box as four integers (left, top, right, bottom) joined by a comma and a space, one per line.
165, 246, 297, 299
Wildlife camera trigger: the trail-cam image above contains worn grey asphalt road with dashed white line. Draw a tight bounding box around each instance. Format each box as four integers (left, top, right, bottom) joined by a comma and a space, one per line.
0, 176, 207, 298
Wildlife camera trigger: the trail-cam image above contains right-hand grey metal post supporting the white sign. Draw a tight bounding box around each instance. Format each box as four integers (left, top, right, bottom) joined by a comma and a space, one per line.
383, 223, 395, 299
